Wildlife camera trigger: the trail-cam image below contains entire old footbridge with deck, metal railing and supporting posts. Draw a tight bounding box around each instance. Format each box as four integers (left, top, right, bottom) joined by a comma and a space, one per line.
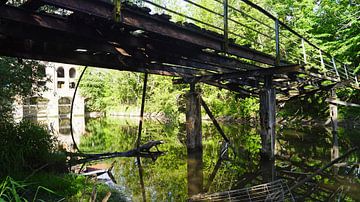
0, 0, 359, 199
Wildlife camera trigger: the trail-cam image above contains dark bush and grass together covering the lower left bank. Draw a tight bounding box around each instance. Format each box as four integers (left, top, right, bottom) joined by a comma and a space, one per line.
0, 120, 124, 202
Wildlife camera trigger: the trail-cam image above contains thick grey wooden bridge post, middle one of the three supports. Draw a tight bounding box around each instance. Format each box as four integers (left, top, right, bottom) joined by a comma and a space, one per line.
260, 75, 276, 159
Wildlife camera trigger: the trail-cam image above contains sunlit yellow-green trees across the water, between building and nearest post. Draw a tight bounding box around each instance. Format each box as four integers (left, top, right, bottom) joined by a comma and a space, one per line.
80, 69, 187, 118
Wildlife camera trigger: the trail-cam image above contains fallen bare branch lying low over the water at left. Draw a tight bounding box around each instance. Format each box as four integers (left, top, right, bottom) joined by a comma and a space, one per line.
67, 140, 164, 165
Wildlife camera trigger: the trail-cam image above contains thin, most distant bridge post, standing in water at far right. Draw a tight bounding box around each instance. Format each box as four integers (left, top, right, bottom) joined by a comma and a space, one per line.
329, 89, 339, 160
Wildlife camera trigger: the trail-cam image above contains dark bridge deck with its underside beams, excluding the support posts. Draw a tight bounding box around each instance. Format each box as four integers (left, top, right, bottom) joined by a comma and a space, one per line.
0, 0, 357, 100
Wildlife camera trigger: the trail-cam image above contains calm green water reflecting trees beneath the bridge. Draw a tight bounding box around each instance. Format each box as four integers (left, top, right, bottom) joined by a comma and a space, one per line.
80, 118, 360, 201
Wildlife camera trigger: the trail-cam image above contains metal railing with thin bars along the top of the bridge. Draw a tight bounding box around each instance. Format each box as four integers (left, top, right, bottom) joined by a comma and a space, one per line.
124, 0, 356, 83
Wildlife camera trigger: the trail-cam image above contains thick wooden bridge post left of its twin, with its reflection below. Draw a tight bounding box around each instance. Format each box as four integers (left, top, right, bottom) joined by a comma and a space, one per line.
186, 84, 203, 197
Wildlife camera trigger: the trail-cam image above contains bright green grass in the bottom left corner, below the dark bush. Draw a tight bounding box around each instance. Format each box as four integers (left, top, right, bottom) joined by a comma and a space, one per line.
0, 172, 126, 202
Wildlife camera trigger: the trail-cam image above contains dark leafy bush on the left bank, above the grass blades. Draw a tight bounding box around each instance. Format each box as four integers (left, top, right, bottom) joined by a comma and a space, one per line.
0, 120, 59, 176
